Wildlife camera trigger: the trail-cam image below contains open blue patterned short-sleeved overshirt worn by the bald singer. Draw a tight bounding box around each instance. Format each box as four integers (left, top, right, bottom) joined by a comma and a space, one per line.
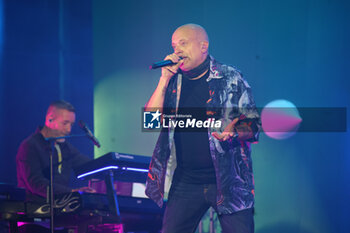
146, 57, 261, 214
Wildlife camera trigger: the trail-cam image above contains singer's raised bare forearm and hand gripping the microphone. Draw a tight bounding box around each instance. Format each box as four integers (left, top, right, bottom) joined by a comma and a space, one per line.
145, 53, 182, 111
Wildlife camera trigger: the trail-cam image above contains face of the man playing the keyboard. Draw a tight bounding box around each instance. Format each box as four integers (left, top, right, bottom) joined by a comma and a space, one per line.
47, 109, 75, 137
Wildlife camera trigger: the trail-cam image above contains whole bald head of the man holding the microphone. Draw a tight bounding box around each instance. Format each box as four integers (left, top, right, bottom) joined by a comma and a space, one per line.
171, 24, 209, 71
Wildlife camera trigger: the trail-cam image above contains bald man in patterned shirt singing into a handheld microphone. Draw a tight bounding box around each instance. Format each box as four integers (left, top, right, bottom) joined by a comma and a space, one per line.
145, 24, 261, 233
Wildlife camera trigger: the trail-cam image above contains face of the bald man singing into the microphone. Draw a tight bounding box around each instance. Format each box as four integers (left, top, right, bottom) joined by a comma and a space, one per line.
171, 29, 206, 71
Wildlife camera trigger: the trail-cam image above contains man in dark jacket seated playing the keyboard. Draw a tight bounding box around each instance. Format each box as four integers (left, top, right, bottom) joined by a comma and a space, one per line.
16, 100, 95, 202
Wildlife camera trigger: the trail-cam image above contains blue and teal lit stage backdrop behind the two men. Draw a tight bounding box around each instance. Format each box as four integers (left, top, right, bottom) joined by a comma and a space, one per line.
0, 0, 350, 233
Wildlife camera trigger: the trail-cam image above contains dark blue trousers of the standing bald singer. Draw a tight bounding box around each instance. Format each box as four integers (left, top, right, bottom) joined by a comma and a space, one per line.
162, 183, 254, 233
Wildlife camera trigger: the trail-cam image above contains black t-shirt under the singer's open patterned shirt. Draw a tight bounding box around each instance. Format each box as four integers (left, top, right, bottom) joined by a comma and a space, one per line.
173, 71, 216, 184
